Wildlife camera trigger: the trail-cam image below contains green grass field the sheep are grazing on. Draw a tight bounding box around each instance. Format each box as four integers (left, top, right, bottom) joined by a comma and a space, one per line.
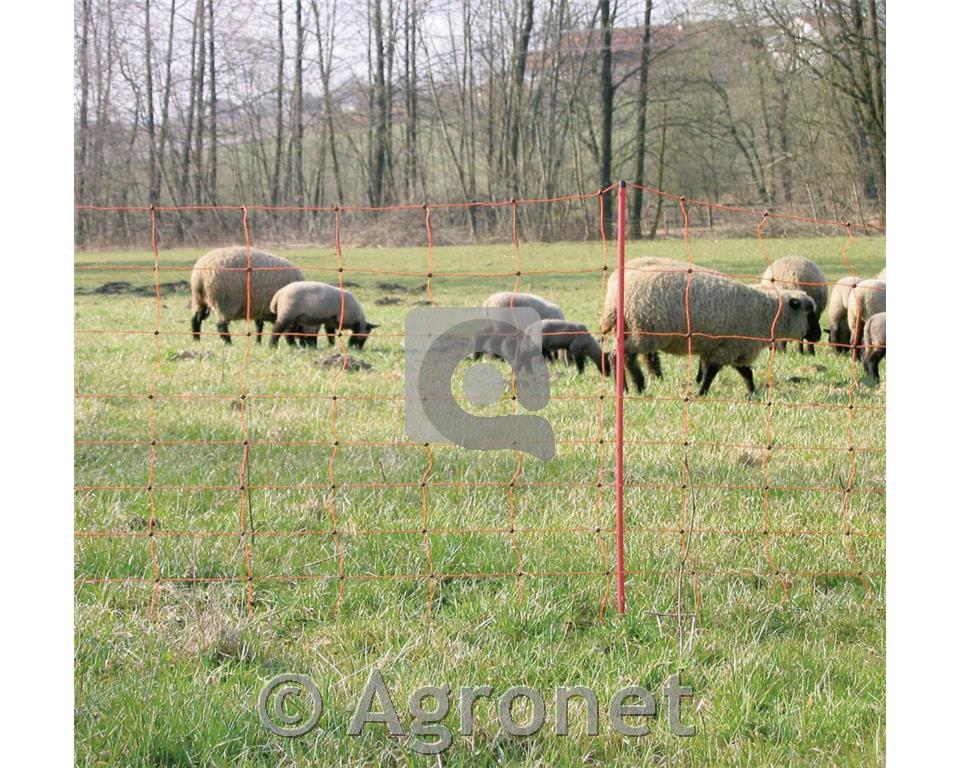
75, 238, 886, 766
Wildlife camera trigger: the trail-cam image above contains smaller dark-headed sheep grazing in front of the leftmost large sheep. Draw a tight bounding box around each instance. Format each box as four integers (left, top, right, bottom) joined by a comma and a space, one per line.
270, 280, 378, 349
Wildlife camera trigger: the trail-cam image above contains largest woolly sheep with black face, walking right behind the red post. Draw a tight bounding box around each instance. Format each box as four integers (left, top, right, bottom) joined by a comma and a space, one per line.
600, 258, 820, 395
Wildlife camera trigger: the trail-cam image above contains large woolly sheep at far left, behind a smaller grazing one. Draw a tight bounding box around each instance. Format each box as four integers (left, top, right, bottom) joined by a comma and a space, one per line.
190, 246, 303, 344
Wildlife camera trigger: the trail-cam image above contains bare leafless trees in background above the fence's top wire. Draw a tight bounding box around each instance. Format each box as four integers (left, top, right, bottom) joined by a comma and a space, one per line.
75, 0, 886, 245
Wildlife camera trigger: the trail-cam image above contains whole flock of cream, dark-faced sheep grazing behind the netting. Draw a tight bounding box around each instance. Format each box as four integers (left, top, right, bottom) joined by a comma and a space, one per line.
190, 247, 886, 395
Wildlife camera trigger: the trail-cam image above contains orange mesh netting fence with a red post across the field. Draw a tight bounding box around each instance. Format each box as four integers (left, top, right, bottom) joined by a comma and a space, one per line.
75, 184, 885, 620
